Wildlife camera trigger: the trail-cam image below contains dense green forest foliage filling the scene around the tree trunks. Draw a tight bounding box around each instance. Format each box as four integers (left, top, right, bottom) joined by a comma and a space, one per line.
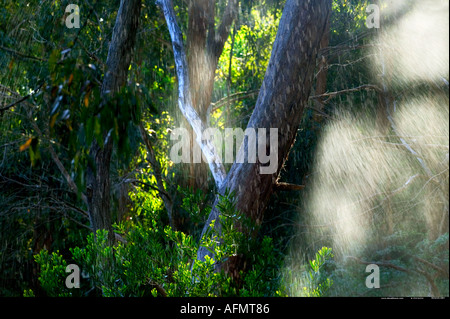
0, 0, 449, 297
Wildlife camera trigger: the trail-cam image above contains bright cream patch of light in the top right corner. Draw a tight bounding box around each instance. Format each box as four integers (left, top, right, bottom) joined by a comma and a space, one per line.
373, 0, 449, 84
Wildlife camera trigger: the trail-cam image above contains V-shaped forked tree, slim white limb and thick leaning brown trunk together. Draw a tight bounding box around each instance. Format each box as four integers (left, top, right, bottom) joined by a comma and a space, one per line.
157, 0, 331, 278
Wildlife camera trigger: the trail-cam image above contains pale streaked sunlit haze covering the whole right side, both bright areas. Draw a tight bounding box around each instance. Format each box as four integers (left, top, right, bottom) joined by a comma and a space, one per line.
284, 1, 449, 296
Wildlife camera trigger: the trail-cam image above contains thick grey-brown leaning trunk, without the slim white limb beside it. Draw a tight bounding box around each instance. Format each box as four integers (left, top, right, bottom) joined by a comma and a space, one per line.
197, 0, 331, 278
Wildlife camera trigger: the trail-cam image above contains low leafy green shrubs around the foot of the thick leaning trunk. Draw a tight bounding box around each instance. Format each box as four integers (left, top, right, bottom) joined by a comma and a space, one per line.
36, 193, 283, 297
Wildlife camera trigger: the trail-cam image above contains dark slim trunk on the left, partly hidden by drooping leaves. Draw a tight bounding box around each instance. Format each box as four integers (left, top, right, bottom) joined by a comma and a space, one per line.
86, 0, 141, 243
